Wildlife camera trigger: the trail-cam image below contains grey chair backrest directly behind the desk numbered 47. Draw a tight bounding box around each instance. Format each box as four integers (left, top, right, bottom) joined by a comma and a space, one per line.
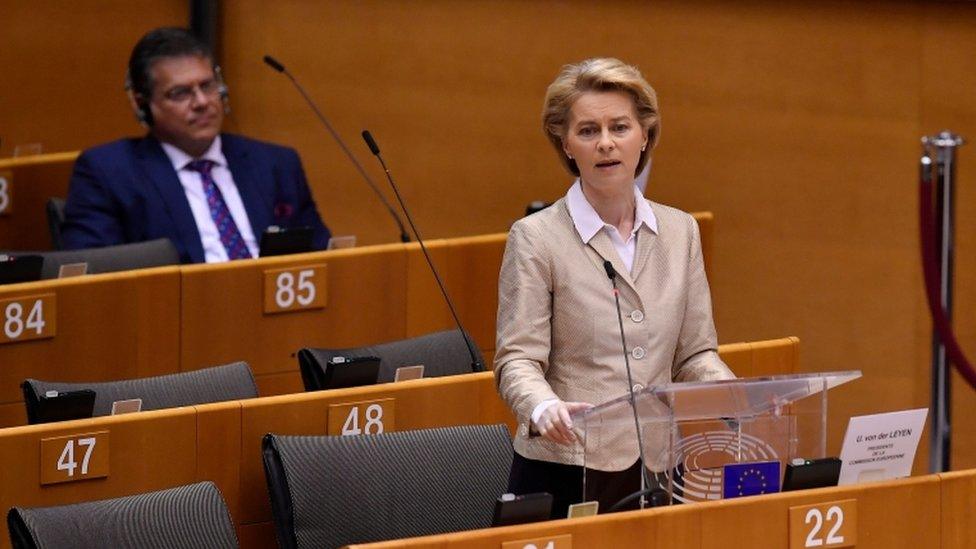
21, 362, 258, 424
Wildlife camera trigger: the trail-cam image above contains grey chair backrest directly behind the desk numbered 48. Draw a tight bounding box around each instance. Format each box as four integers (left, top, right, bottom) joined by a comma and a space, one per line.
298, 330, 484, 391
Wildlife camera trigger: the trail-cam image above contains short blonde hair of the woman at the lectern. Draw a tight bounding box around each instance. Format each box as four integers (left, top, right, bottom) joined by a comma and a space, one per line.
542, 57, 661, 177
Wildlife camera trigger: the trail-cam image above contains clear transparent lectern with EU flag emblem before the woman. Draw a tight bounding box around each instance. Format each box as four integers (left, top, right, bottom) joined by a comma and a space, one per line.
574, 371, 861, 503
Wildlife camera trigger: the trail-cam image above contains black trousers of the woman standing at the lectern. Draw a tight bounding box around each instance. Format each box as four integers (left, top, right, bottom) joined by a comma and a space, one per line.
508, 452, 654, 519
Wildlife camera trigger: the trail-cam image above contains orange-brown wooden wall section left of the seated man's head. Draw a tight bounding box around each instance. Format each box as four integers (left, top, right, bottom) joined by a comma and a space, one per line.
0, 0, 189, 156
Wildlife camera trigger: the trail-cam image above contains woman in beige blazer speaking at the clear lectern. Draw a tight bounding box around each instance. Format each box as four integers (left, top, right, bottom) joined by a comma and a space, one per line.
495, 58, 735, 518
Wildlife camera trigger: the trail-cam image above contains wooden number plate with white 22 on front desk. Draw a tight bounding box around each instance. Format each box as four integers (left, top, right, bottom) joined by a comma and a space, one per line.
790, 499, 857, 549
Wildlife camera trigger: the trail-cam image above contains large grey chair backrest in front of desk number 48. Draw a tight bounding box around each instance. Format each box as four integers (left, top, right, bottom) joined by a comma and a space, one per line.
262, 425, 512, 549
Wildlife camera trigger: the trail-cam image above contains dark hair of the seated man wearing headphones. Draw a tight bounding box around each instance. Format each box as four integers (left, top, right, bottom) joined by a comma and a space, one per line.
128, 27, 213, 99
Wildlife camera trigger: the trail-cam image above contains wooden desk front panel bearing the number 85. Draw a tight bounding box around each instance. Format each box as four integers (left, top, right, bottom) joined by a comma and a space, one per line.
180, 244, 406, 376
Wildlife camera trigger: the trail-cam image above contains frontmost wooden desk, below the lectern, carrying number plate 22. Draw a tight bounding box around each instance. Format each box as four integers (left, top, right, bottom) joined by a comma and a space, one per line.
349, 471, 952, 549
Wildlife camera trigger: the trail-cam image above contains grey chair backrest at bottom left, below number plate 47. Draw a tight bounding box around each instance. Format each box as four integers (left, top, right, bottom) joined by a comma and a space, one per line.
7, 482, 238, 549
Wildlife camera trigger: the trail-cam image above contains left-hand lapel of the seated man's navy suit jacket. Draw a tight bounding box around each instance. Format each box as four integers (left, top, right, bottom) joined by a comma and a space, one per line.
137, 136, 204, 263
